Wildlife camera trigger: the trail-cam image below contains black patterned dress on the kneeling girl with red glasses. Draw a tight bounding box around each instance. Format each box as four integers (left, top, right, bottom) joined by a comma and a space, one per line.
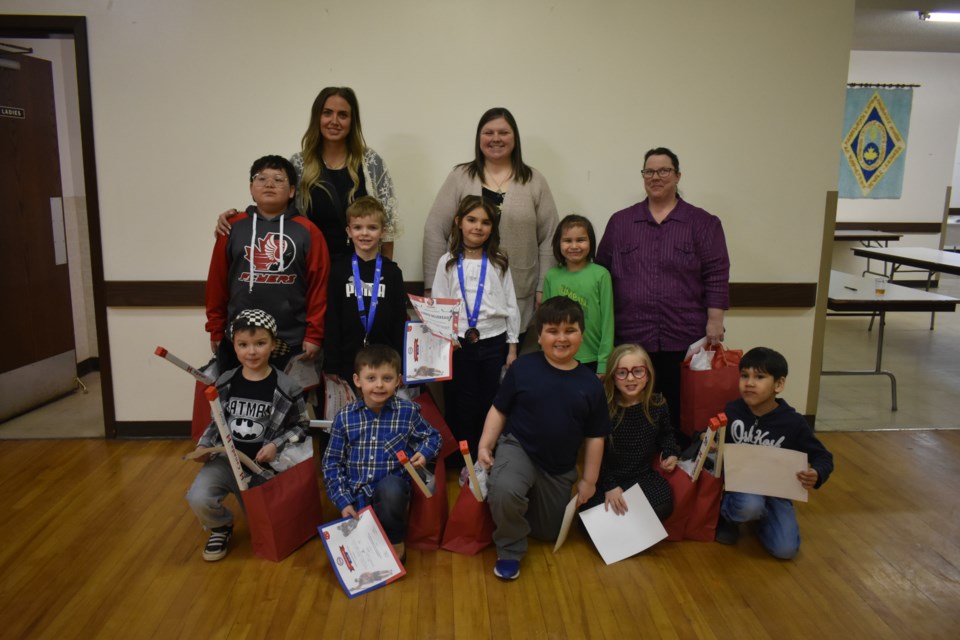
584, 394, 682, 520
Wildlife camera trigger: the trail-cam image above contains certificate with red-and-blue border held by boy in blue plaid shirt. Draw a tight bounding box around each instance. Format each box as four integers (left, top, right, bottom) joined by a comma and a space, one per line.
319, 507, 407, 598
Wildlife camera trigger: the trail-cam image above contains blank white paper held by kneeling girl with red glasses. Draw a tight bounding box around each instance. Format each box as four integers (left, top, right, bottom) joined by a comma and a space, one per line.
580, 484, 667, 564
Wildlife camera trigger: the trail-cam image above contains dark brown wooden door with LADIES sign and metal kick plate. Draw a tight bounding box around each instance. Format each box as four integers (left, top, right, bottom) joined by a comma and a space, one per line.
0, 56, 76, 420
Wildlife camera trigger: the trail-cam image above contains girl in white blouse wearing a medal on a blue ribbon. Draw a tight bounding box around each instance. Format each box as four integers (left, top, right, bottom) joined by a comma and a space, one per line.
432, 196, 520, 459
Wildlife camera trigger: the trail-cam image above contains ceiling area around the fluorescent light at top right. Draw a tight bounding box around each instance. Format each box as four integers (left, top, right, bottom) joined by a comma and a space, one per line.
853, 0, 960, 51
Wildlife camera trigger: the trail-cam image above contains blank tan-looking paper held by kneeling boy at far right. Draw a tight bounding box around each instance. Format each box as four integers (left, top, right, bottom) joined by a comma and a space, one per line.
723, 444, 808, 502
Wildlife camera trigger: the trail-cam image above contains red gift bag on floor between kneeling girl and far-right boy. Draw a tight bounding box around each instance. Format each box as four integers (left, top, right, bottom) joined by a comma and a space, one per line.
653, 460, 723, 542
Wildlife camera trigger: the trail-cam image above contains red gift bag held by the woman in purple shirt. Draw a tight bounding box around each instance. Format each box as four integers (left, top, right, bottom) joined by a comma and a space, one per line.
680, 344, 743, 436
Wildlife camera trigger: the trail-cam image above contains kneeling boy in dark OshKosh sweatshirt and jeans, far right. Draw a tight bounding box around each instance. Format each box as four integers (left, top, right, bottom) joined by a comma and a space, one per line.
717, 347, 833, 560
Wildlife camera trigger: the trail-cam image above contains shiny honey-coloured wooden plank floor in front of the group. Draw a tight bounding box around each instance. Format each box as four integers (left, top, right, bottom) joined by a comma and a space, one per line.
0, 431, 960, 640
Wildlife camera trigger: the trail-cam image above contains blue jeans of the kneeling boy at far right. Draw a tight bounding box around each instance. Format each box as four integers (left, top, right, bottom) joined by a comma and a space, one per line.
720, 491, 800, 560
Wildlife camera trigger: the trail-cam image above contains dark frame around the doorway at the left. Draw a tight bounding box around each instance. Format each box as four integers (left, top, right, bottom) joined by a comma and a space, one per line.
0, 15, 117, 438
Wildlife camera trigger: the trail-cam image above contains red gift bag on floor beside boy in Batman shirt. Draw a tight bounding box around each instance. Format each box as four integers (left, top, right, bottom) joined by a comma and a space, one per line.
241, 458, 323, 562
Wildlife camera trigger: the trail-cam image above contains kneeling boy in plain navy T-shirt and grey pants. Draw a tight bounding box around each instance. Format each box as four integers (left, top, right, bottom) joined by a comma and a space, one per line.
477, 297, 610, 580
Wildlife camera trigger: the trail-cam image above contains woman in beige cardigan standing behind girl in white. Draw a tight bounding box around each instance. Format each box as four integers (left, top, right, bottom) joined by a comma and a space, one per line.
423, 107, 557, 331
